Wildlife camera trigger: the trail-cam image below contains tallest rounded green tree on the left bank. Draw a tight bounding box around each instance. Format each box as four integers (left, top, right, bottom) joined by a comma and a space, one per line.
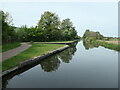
37, 11, 61, 41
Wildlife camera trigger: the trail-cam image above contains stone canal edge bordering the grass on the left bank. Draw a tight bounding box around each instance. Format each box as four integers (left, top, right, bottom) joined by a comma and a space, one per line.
0, 45, 70, 77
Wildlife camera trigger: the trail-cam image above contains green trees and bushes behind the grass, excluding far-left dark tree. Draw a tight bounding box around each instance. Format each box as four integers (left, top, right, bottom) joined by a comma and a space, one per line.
17, 11, 79, 42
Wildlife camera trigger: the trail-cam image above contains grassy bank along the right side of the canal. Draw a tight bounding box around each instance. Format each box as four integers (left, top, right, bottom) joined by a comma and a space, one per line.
93, 41, 120, 51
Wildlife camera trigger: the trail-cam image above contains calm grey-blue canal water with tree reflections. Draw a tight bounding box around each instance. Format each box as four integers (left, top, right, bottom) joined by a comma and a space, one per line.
3, 41, 118, 88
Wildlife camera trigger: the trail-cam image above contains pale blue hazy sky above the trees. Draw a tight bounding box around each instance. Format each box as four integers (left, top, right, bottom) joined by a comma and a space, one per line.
2, 2, 118, 37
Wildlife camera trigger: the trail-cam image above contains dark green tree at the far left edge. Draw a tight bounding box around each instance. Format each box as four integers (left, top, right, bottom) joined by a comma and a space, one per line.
0, 11, 17, 43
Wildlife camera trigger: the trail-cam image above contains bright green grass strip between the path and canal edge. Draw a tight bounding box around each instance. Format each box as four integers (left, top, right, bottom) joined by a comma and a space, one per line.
2, 44, 64, 71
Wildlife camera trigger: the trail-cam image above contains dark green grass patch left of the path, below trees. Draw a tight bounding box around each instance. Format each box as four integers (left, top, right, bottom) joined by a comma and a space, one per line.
0, 42, 21, 52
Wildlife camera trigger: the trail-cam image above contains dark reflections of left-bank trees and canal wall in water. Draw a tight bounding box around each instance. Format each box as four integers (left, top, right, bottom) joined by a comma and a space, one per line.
2, 43, 77, 89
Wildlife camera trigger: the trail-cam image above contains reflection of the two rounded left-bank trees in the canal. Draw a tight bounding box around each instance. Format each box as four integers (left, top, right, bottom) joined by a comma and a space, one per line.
40, 43, 77, 72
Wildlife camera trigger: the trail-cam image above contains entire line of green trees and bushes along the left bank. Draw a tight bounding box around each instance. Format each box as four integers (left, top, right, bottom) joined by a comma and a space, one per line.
0, 11, 79, 43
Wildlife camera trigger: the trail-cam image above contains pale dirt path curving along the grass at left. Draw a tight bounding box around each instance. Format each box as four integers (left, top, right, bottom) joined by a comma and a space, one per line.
0, 43, 31, 61
